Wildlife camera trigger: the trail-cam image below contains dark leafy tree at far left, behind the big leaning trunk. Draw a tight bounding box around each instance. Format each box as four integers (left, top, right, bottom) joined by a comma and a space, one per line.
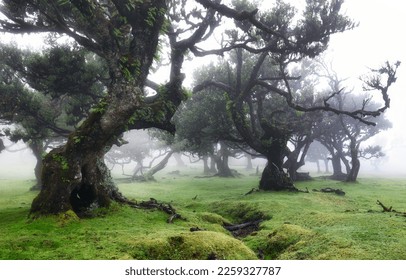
0, 44, 108, 189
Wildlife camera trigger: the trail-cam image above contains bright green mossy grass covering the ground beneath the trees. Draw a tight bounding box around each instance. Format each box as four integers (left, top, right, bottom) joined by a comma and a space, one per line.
0, 172, 406, 260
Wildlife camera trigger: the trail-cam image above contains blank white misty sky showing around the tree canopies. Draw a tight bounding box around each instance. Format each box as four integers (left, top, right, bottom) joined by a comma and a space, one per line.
0, 0, 406, 176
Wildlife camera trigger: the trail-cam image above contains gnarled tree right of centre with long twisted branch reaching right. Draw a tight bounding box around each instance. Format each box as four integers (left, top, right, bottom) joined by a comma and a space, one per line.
194, 0, 398, 190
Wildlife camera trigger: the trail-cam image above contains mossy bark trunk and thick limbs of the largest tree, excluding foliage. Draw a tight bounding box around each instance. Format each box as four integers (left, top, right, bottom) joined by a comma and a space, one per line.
31, 0, 173, 215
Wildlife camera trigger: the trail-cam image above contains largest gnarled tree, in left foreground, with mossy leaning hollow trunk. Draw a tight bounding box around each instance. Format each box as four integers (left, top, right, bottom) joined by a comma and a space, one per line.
0, 0, 217, 214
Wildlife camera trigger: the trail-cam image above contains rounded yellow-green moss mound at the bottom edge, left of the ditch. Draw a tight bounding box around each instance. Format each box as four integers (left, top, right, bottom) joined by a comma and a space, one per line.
126, 231, 256, 260
